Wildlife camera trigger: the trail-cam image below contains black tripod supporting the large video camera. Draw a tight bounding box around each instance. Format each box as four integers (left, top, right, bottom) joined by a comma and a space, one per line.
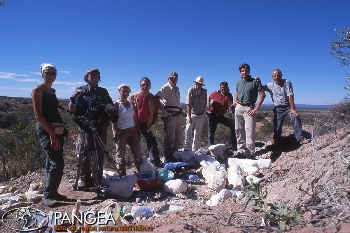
73, 120, 109, 196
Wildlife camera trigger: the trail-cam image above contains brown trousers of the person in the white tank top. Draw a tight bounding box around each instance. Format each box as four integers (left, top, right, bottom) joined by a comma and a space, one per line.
116, 126, 143, 175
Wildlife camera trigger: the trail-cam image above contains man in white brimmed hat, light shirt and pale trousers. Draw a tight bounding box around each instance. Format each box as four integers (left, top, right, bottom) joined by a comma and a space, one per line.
185, 76, 207, 150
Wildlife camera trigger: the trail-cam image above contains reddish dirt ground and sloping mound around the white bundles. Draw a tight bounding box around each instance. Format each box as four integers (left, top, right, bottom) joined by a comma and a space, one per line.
0, 128, 350, 233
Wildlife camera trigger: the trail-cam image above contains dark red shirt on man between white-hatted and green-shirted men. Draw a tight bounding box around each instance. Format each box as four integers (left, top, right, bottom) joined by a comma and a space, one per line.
209, 91, 233, 115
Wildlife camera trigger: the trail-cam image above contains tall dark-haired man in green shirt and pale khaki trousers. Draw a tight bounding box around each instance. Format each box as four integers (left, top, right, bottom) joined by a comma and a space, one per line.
234, 63, 265, 158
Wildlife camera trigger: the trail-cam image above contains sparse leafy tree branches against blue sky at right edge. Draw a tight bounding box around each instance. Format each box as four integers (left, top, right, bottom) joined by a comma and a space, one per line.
330, 28, 350, 98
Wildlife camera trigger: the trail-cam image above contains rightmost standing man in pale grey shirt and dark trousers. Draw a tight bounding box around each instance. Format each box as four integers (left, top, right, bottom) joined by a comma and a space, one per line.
264, 69, 305, 155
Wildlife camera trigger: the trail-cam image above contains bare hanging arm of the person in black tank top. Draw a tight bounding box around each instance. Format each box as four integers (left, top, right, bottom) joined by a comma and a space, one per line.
32, 87, 61, 150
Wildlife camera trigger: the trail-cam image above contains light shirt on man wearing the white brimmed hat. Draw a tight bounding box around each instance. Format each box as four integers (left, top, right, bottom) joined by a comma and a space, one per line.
186, 87, 207, 115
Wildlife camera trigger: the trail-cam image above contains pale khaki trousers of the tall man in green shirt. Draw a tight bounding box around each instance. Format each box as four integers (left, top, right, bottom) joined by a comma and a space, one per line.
235, 104, 256, 157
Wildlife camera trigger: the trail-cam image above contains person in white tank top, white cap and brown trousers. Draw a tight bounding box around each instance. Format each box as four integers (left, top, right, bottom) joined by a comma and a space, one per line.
112, 84, 143, 176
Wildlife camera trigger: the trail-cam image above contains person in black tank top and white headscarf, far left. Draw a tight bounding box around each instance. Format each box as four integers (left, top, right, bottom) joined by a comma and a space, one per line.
32, 63, 67, 207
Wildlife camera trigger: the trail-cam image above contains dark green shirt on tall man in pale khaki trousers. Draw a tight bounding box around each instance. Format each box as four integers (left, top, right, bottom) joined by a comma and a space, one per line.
236, 76, 263, 105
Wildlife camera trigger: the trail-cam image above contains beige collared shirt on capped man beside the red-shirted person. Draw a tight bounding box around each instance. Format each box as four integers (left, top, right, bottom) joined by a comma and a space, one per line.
156, 82, 181, 111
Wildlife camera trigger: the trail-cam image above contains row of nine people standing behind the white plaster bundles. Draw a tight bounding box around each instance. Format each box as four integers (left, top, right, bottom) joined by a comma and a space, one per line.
32, 63, 303, 207
